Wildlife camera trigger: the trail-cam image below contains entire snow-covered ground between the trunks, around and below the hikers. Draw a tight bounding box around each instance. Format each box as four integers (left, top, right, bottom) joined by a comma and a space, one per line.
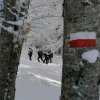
15, 46, 62, 100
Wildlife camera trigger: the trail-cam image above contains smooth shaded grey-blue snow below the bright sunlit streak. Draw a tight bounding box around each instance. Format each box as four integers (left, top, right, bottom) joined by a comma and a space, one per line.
15, 80, 60, 100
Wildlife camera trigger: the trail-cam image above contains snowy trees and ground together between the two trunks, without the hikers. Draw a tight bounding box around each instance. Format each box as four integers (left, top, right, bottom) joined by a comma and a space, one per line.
16, 0, 63, 100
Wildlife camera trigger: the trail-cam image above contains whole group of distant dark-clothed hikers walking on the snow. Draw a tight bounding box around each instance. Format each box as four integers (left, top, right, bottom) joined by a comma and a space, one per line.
28, 48, 53, 64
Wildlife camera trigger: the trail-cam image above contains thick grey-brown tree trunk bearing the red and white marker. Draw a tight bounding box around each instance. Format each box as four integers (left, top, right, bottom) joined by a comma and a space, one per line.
61, 0, 100, 100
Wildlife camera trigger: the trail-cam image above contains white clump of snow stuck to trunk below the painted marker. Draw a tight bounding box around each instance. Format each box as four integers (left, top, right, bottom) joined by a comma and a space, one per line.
82, 49, 100, 63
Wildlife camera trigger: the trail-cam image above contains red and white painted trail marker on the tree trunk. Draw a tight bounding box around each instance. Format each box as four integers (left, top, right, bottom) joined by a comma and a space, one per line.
69, 32, 96, 48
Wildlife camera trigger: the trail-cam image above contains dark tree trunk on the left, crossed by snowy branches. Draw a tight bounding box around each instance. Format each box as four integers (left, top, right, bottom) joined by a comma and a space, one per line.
0, 0, 29, 100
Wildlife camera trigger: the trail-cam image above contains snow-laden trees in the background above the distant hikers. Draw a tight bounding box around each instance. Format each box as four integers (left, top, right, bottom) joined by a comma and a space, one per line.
27, 0, 63, 52
